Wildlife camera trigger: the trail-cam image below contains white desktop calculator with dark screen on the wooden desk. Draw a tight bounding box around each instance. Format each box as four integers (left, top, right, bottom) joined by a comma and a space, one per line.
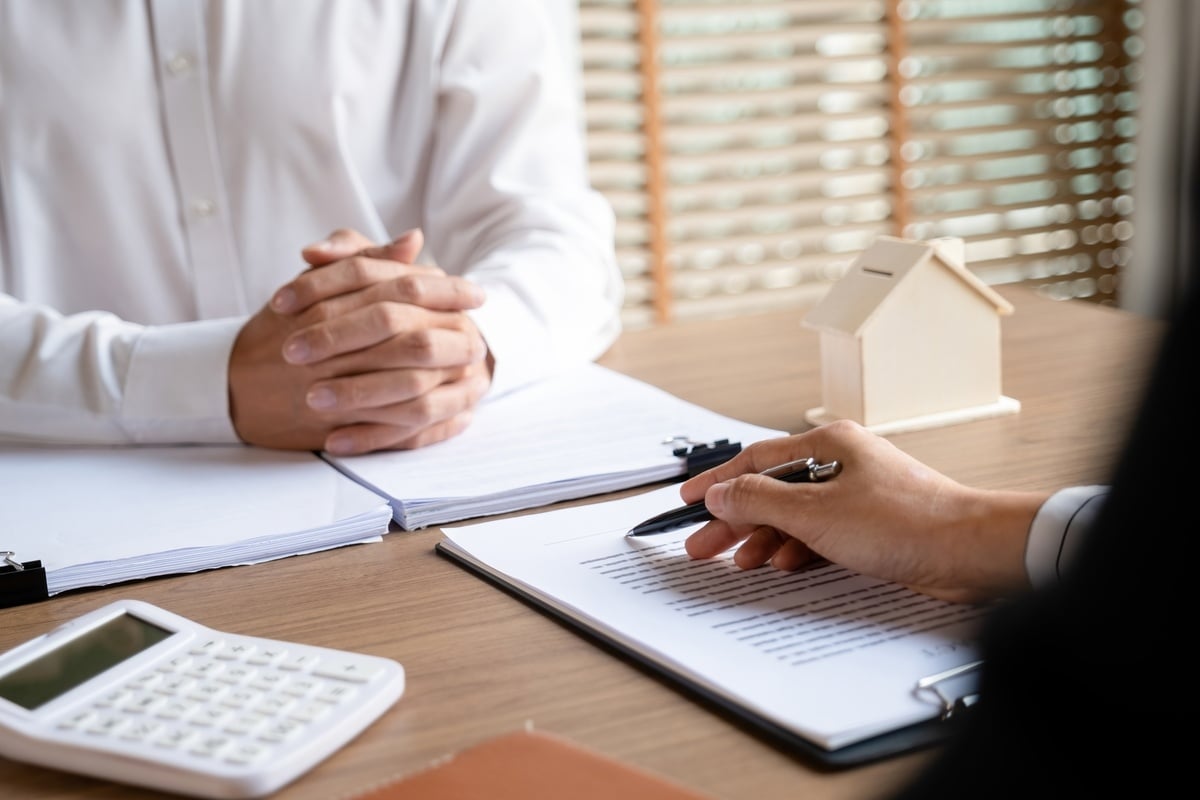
0, 600, 404, 798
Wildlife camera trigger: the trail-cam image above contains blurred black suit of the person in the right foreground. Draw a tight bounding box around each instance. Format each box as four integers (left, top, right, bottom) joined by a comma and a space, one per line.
896, 281, 1200, 800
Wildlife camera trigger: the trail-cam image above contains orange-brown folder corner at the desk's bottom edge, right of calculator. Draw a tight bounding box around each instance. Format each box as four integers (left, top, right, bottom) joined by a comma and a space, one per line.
349, 730, 709, 800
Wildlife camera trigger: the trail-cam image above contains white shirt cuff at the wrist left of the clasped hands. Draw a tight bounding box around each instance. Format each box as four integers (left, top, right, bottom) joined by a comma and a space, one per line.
121, 318, 246, 444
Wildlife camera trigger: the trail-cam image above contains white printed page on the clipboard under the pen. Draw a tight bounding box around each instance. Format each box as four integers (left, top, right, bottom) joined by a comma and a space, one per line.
439, 486, 985, 750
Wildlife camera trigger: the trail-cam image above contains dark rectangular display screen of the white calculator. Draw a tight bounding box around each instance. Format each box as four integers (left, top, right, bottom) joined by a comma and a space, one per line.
0, 613, 172, 710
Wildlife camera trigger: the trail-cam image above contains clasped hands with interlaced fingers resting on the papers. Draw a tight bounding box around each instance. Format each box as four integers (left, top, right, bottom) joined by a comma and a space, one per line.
228, 229, 492, 455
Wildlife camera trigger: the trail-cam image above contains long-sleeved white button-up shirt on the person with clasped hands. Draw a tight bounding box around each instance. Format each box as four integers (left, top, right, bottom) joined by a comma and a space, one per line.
0, 0, 622, 444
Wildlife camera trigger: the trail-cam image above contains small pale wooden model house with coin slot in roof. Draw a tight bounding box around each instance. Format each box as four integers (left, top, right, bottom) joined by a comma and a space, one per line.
804, 236, 1020, 433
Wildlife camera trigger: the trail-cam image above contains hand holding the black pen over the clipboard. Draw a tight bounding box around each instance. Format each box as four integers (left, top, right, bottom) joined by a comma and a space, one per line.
679, 420, 1049, 602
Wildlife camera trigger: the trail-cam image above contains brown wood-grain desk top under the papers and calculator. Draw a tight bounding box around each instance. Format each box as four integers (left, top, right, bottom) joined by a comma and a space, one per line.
0, 289, 1160, 800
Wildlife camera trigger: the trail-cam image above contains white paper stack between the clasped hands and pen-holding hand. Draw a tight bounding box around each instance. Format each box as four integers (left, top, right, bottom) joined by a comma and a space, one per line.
324, 363, 785, 530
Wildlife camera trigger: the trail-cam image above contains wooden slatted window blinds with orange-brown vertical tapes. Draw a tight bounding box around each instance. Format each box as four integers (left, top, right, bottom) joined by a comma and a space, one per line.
580, 0, 1141, 327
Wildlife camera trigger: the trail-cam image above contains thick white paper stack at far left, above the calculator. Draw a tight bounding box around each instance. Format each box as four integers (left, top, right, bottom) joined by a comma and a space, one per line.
0, 446, 391, 595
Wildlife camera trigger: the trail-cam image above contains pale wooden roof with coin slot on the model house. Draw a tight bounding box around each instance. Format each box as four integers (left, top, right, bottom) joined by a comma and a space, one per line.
804, 236, 1013, 336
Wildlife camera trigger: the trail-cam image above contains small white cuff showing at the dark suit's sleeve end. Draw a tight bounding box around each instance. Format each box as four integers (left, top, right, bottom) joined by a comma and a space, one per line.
1025, 486, 1109, 588
